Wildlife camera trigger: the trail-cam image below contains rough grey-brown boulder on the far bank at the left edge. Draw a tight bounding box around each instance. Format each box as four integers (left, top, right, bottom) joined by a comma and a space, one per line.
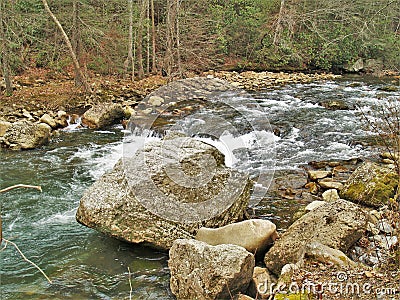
3, 121, 51, 150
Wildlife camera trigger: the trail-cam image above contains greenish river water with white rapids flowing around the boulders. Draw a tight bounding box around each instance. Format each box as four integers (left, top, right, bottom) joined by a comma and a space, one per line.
0, 75, 400, 299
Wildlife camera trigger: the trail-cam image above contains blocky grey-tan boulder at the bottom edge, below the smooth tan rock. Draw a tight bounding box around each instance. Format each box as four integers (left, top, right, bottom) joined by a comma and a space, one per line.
168, 239, 255, 300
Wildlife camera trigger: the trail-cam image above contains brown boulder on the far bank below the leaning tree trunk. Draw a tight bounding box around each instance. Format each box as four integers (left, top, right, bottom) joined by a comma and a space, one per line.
82, 103, 125, 129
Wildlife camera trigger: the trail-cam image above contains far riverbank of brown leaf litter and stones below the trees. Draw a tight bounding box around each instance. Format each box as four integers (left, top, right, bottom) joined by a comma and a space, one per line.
0, 71, 344, 150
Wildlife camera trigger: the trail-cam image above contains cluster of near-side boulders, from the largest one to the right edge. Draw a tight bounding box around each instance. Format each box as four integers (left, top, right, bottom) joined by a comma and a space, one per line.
77, 134, 398, 299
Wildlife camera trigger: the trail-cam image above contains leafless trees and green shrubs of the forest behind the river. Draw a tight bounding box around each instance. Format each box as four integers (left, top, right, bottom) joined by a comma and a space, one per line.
0, 0, 400, 85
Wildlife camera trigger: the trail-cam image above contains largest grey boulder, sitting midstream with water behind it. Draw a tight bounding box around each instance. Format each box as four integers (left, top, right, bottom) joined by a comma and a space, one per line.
76, 136, 251, 250
